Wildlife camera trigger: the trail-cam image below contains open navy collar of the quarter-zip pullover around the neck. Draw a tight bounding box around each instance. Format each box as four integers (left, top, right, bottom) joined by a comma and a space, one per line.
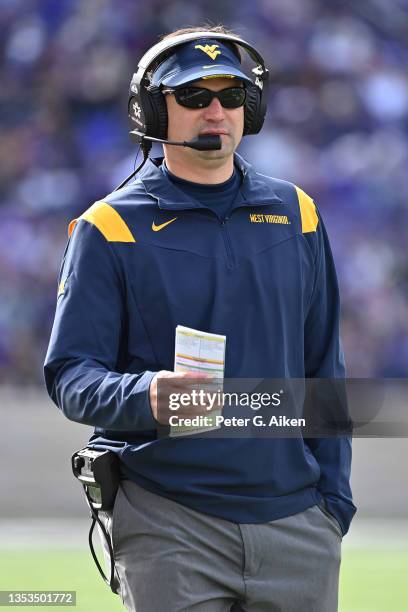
138, 153, 282, 210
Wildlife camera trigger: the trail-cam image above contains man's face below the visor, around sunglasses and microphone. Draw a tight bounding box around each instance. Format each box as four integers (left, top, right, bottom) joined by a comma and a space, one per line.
165, 78, 244, 160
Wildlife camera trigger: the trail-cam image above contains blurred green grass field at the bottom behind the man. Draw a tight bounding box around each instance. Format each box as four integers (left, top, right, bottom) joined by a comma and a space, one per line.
0, 549, 408, 612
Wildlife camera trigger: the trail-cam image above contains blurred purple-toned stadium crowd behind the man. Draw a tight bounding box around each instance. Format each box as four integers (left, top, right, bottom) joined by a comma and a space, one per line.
0, 0, 408, 384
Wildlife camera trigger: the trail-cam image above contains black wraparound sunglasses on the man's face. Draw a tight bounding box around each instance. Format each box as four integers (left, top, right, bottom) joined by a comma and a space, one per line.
162, 87, 246, 108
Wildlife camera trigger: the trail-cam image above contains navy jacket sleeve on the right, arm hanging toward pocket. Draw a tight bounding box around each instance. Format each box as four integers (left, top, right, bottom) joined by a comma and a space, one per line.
304, 210, 356, 534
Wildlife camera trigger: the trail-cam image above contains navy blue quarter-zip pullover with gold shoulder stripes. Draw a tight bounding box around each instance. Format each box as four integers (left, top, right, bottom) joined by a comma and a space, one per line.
45, 155, 355, 533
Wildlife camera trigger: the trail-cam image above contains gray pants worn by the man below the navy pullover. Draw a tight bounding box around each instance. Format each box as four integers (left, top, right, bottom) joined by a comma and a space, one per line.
101, 480, 341, 612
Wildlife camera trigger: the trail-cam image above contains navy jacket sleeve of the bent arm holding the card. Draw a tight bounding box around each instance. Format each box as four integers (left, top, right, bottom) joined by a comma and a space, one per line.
44, 219, 157, 431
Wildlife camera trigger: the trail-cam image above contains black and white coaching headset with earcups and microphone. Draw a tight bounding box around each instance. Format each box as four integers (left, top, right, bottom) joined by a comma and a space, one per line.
115, 31, 269, 191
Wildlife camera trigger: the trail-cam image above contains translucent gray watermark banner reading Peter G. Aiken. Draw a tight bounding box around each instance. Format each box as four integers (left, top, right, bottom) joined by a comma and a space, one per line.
158, 378, 408, 438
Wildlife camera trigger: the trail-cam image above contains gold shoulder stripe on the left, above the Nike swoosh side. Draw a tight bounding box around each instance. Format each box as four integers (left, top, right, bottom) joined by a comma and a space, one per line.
68, 202, 136, 242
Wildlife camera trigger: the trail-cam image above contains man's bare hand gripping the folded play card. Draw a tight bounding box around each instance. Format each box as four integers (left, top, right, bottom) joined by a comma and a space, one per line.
150, 370, 218, 425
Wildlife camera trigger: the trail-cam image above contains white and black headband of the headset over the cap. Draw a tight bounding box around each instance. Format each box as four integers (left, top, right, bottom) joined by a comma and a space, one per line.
137, 31, 268, 89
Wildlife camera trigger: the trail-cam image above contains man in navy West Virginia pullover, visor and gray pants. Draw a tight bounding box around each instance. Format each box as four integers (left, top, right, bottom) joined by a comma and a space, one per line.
45, 28, 355, 612
